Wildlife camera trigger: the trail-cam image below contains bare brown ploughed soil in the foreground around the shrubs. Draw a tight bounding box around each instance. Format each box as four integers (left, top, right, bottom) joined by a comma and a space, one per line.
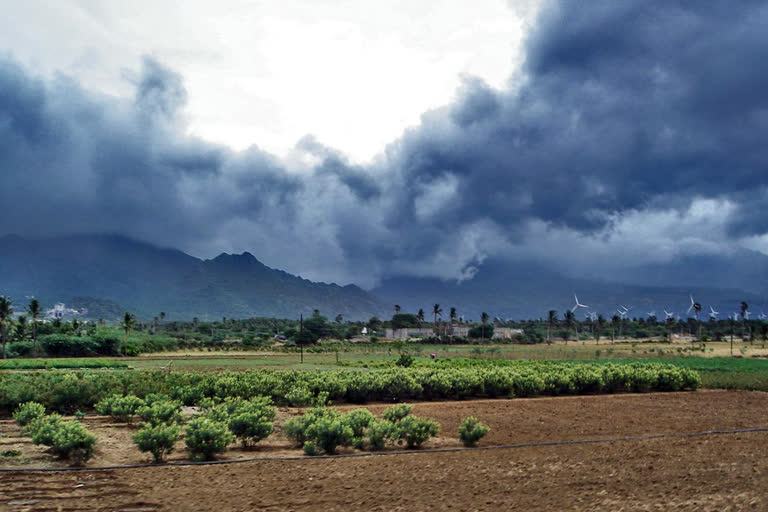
0, 391, 768, 511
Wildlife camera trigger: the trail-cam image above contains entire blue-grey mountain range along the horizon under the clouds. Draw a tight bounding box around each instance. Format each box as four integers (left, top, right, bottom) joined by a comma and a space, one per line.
0, 235, 768, 320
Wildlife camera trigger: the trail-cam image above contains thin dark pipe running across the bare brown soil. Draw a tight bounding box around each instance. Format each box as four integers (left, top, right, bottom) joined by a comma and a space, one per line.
0, 427, 768, 473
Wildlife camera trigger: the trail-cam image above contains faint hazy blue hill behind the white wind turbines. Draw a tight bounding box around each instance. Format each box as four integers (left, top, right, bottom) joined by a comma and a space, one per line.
371, 261, 768, 320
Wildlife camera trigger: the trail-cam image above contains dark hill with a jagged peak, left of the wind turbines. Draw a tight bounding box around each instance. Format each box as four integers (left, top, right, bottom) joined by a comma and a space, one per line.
0, 235, 389, 320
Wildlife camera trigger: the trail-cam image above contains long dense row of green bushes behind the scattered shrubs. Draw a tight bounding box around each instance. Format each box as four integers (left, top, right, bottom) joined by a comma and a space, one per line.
0, 363, 701, 414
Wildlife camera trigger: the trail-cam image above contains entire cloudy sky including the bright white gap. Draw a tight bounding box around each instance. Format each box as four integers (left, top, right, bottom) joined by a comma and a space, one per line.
0, 0, 768, 286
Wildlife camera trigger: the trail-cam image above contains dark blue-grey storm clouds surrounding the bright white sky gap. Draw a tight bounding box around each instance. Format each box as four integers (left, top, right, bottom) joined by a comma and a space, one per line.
0, 0, 768, 284
